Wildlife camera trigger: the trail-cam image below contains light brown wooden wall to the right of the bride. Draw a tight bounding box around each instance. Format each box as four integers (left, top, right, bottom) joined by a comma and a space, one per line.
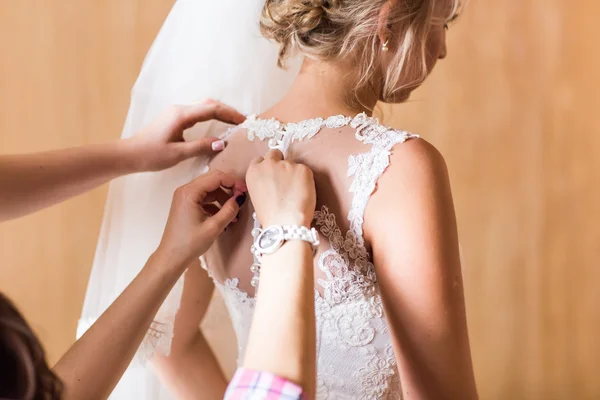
384, 0, 600, 399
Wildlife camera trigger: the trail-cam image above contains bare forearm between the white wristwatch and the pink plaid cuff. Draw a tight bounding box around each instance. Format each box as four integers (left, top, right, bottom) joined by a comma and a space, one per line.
243, 241, 316, 398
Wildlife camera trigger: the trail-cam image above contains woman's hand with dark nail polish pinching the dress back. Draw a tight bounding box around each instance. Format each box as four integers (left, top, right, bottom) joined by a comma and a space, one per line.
157, 170, 247, 266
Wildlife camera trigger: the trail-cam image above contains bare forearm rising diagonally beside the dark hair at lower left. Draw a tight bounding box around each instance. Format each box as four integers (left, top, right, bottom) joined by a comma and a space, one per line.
54, 254, 184, 399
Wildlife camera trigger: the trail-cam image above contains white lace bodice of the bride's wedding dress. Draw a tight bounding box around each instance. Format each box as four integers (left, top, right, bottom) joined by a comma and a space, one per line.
208, 114, 415, 399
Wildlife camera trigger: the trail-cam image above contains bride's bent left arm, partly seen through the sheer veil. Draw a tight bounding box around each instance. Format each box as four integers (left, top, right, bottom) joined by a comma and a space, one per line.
155, 261, 227, 400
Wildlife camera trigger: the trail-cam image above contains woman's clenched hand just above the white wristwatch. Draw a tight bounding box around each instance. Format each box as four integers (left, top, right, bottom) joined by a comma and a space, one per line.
246, 150, 316, 227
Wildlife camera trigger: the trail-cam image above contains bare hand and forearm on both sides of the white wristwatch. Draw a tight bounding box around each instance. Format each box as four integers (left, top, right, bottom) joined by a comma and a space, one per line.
243, 150, 316, 398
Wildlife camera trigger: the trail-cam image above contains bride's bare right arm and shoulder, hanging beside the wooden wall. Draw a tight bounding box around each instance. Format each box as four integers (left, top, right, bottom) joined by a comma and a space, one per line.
365, 140, 477, 400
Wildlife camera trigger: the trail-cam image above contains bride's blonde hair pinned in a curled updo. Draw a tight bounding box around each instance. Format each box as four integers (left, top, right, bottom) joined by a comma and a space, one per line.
260, 0, 459, 101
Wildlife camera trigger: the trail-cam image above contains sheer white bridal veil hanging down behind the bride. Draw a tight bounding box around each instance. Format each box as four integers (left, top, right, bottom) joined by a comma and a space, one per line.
77, 0, 298, 400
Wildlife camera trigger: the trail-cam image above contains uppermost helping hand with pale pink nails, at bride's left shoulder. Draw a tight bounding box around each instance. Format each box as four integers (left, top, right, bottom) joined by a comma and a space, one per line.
123, 100, 246, 172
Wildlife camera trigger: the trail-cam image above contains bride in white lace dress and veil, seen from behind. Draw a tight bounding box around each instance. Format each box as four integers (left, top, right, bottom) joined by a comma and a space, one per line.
81, 0, 477, 399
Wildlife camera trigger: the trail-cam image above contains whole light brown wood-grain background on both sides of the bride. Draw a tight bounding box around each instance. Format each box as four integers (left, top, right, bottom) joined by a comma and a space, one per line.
0, 0, 600, 400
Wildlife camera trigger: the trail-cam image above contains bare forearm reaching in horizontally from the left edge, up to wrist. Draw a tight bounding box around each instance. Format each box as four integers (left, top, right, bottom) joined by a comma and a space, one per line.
0, 141, 136, 221
